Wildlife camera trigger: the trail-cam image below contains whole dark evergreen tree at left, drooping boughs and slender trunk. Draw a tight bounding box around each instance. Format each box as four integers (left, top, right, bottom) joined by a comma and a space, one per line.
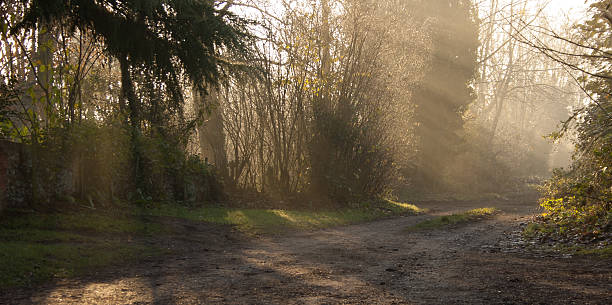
12, 0, 249, 191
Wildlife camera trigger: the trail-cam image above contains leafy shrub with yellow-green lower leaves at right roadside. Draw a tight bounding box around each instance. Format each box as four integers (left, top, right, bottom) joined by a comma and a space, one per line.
540, 82, 612, 239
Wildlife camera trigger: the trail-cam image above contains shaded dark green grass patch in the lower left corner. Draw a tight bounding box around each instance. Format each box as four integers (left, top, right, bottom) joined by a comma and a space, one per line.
0, 211, 163, 288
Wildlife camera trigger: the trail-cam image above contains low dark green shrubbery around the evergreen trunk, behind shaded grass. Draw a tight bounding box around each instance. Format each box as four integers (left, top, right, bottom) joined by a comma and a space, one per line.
0, 121, 221, 206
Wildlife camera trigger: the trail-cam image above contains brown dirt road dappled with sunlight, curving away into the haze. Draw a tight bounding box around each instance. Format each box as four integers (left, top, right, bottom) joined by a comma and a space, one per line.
0, 200, 612, 304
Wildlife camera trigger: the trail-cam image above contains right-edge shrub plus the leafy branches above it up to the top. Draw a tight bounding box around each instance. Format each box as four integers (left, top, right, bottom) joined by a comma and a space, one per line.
528, 1, 612, 242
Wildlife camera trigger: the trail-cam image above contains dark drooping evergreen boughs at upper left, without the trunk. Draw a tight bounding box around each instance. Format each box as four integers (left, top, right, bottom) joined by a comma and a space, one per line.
13, 0, 248, 90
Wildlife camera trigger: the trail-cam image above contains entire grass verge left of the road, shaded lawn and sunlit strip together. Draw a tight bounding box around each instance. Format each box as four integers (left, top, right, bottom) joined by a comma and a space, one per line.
0, 200, 421, 289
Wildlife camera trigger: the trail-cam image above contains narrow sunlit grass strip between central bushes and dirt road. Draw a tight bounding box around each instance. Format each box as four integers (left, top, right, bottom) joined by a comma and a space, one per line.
137, 200, 421, 233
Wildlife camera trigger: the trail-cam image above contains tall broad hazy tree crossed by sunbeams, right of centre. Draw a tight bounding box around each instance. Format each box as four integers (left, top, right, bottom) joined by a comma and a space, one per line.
413, 0, 478, 190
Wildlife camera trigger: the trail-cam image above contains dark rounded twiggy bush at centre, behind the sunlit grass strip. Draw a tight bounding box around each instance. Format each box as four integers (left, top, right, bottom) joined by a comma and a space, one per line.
310, 104, 397, 203
